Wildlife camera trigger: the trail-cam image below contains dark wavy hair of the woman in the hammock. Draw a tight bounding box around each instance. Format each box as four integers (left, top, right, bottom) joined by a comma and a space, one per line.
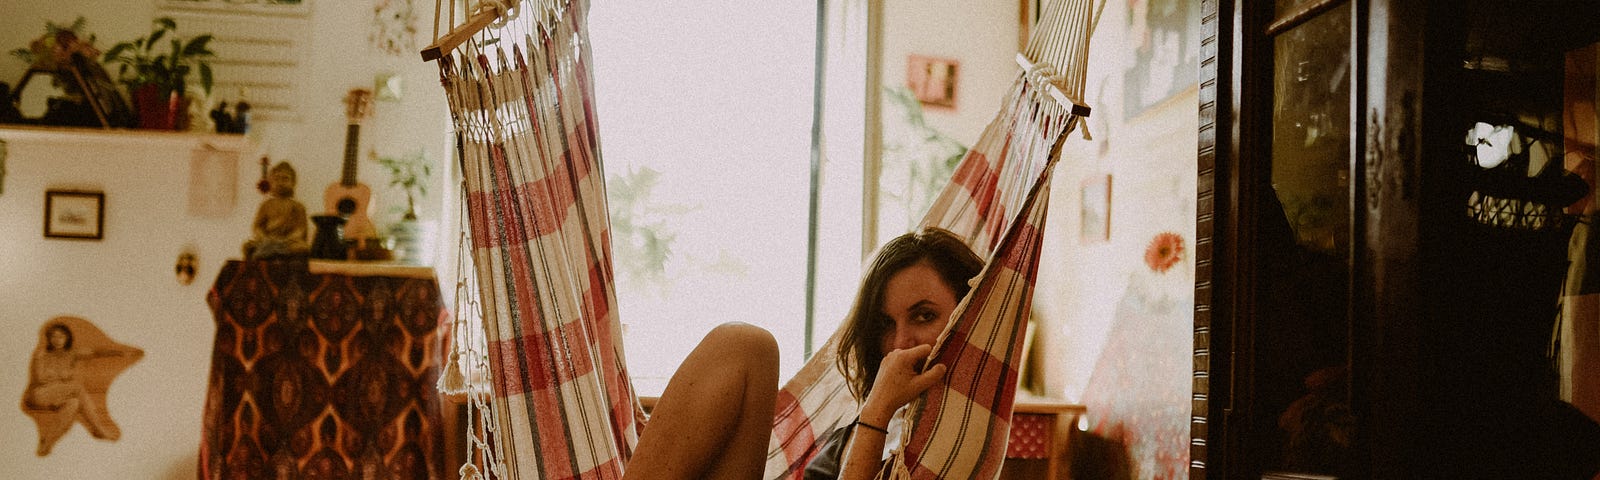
835, 227, 984, 400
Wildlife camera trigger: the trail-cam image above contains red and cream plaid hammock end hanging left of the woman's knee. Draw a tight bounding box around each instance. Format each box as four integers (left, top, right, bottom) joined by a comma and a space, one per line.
440, 0, 638, 478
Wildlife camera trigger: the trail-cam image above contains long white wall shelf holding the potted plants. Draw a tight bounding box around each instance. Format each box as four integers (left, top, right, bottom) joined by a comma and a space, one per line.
0, 125, 256, 152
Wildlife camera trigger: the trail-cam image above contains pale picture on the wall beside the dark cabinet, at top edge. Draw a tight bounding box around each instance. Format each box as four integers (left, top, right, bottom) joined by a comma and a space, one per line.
1122, 0, 1200, 118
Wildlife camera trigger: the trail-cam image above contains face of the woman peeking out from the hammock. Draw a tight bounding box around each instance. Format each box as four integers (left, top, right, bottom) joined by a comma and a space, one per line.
880, 261, 958, 355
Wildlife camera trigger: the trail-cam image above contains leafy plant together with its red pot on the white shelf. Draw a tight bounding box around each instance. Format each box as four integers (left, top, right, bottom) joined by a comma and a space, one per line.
102, 16, 216, 130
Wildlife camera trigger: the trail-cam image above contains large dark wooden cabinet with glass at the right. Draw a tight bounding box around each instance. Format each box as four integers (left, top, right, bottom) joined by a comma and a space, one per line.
1190, 0, 1600, 478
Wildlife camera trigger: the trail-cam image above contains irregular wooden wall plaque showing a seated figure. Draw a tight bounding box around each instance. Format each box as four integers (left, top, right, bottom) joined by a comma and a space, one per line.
22, 317, 144, 456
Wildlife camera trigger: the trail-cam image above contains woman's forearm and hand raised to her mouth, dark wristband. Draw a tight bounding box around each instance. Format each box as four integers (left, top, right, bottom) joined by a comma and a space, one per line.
838, 346, 944, 480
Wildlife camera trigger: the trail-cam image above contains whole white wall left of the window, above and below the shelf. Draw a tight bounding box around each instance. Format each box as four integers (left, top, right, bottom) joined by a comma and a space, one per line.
0, 0, 454, 478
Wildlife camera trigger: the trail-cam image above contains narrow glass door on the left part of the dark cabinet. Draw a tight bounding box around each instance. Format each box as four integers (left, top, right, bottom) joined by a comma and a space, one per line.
1245, 0, 1357, 478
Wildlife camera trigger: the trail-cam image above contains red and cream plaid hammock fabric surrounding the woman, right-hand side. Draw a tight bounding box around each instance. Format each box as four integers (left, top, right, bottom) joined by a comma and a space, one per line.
766, 75, 1075, 480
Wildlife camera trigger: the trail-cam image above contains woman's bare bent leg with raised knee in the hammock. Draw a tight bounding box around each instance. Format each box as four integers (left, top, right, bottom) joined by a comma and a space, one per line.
626, 323, 778, 480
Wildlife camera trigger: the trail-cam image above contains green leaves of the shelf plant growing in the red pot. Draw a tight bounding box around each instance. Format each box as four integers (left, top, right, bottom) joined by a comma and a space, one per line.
101, 16, 216, 96
